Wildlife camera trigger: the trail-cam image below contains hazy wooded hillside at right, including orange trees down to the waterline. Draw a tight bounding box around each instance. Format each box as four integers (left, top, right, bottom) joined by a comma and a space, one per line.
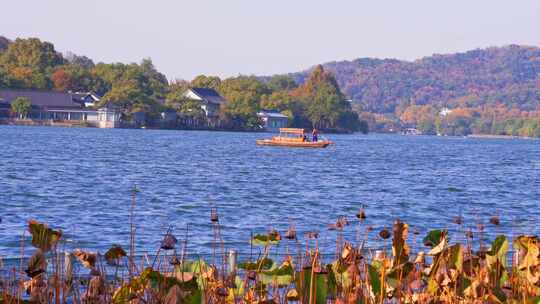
291, 45, 540, 136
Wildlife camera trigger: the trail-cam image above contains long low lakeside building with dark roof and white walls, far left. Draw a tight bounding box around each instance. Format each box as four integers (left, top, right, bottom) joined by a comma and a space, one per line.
0, 89, 120, 128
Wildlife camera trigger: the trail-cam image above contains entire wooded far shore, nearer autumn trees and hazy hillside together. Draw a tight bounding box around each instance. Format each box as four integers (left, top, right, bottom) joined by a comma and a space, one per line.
0, 37, 540, 137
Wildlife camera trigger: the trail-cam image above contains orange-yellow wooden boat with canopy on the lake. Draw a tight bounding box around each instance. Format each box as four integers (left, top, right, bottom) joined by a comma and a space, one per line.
257, 128, 333, 148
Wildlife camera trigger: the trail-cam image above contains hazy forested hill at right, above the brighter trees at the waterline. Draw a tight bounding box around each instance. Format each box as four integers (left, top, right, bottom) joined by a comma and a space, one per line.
291, 45, 540, 115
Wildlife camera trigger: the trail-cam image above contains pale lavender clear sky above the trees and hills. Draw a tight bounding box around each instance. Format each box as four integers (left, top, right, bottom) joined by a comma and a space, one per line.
0, 0, 540, 80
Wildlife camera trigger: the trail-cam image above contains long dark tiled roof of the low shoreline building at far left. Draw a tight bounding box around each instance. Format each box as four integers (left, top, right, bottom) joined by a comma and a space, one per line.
0, 89, 84, 109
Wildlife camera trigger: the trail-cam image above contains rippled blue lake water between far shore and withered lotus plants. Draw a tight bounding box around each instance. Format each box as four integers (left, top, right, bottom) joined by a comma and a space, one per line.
0, 126, 540, 258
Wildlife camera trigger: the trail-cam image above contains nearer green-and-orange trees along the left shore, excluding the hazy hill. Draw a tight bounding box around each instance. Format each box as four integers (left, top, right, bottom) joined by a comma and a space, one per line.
0, 38, 367, 132
